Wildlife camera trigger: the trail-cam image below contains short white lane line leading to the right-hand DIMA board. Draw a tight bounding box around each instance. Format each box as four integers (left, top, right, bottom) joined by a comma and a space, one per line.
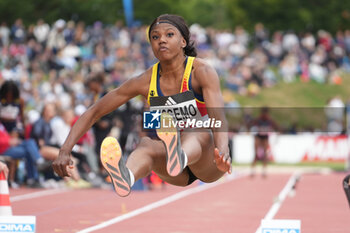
255, 173, 300, 233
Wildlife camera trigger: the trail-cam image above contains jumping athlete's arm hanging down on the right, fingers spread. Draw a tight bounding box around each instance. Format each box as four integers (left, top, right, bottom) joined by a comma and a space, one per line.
195, 64, 231, 173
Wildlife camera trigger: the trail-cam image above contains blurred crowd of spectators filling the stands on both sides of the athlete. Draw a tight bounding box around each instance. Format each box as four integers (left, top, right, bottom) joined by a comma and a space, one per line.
0, 19, 350, 186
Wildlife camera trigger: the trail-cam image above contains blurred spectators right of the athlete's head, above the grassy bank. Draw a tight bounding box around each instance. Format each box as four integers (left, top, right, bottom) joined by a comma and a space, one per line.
191, 23, 350, 95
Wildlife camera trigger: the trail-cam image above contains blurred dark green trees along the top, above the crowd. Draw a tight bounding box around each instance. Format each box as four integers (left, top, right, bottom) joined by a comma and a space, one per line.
0, 0, 350, 33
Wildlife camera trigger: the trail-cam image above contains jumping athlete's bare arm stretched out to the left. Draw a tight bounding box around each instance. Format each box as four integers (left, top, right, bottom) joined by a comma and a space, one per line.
52, 74, 148, 177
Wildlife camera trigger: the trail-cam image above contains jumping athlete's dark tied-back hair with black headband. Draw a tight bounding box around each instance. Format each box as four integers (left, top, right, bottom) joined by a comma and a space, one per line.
148, 14, 197, 57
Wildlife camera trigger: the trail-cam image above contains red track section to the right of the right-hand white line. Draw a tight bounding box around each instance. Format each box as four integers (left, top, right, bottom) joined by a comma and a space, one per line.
275, 173, 350, 233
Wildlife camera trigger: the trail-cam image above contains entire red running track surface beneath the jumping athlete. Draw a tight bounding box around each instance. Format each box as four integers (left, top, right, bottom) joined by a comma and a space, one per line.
6, 171, 350, 233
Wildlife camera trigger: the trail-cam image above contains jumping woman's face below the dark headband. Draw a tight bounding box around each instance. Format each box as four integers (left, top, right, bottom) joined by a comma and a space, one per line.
150, 23, 186, 60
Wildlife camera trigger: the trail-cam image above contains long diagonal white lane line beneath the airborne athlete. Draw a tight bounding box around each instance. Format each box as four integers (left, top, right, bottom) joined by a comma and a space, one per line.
78, 174, 247, 233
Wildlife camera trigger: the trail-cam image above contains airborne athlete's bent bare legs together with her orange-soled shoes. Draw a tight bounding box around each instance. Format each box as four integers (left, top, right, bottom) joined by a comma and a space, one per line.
100, 125, 225, 196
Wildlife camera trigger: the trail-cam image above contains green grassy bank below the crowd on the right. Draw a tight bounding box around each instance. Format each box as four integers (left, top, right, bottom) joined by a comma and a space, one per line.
228, 75, 350, 131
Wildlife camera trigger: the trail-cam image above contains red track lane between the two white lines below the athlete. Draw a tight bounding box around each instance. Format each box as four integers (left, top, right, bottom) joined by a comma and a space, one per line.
96, 175, 289, 233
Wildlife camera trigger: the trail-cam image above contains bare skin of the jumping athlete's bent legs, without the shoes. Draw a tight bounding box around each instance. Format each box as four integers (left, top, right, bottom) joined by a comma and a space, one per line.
126, 131, 224, 186
